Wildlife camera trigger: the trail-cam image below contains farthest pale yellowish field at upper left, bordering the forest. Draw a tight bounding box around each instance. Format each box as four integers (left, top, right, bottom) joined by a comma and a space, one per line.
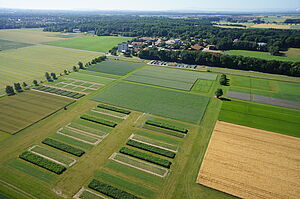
0, 29, 82, 44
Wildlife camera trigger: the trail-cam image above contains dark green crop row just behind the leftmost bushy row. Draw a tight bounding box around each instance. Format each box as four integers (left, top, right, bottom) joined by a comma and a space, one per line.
42, 138, 85, 157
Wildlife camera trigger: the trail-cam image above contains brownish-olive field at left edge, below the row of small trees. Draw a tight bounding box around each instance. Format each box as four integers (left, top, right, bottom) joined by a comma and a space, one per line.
0, 91, 73, 134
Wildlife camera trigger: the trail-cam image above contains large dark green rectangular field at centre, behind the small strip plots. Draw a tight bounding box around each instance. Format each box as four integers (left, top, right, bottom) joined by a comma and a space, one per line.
93, 82, 209, 124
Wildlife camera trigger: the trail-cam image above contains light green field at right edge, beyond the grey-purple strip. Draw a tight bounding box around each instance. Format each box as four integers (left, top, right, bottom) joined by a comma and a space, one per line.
230, 75, 300, 101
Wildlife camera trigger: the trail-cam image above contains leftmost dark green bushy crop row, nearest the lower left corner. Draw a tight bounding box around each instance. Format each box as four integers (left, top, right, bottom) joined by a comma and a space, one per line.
19, 151, 66, 174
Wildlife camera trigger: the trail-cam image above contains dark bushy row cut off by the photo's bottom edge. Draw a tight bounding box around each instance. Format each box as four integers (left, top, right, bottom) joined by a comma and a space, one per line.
88, 179, 140, 199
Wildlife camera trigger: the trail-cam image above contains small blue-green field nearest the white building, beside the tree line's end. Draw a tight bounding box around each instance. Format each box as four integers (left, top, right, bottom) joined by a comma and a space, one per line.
86, 61, 143, 75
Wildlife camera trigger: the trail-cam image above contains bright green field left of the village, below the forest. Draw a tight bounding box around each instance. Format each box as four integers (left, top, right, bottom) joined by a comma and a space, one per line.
49, 36, 132, 52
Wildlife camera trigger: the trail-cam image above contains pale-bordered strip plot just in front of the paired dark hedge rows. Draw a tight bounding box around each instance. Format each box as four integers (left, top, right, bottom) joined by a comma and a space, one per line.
109, 153, 168, 177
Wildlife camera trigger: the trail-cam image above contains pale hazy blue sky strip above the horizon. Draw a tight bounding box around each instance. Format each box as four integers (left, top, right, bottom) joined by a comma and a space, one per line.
0, 0, 300, 11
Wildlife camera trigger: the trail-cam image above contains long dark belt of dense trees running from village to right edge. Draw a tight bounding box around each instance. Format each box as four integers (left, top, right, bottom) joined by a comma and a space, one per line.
139, 48, 300, 77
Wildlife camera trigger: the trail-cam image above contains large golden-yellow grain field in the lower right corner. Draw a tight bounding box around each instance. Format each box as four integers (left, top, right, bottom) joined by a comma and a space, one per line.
197, 121, 300, 199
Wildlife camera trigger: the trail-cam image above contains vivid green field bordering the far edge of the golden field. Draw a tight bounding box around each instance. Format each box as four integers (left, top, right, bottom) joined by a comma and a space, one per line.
219, 100, 300, 137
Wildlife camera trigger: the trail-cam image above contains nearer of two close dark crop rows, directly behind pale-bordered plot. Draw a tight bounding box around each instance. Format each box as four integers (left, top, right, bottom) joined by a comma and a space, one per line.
119, 147, 172, 168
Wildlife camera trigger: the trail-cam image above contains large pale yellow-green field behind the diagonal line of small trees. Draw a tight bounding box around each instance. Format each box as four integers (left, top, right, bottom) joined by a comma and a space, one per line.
0, 46, 99, 93
